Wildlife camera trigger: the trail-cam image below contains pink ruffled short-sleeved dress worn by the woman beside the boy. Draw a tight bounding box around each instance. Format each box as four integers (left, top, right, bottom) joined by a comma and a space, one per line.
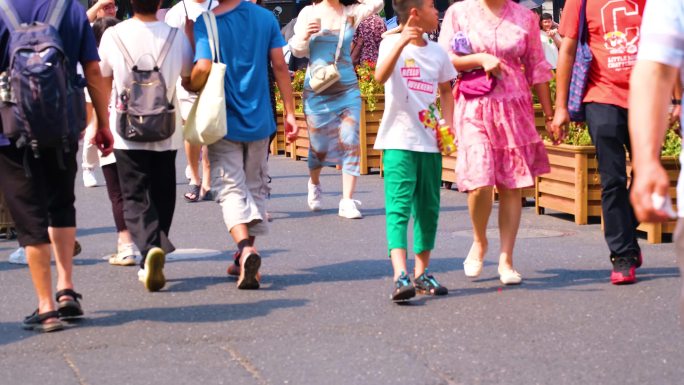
439, 0, 553, 191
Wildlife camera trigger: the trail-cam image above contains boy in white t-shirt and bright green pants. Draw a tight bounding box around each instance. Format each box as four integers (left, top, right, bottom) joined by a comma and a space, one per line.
375, 0, 456, 302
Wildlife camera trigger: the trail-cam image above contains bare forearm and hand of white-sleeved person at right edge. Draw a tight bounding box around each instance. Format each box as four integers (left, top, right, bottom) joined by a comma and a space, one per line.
629, 60, 678, 221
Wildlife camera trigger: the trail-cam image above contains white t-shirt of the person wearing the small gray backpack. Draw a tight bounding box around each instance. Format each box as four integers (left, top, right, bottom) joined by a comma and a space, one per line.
99, 19, 193, 151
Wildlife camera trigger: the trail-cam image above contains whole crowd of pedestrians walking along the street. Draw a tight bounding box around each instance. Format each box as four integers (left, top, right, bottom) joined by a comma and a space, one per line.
0, 0, 684, 332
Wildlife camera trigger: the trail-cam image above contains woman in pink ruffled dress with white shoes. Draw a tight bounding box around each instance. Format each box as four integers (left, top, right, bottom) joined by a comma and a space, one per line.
439, 0, 560, 285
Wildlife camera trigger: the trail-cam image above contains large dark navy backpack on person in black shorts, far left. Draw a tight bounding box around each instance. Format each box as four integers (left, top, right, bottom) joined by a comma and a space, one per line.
0, 0, 86, 160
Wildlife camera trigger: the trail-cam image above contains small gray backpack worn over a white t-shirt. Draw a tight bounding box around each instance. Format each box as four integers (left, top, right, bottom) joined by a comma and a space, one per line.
112, 28, 178, 142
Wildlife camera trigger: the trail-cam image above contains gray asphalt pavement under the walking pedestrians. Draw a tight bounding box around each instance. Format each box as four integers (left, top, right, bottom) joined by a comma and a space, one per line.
0, 154, 684, 385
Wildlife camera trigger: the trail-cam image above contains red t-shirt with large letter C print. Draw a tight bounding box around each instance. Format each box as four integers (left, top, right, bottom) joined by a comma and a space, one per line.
559, 0, 657, 108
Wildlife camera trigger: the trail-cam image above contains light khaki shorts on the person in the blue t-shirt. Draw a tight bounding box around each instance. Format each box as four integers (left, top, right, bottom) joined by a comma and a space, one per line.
208, 138, 269, 236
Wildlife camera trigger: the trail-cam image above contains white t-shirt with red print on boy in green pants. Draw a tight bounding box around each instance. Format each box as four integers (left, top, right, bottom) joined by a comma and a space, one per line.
373, 34, 457, 153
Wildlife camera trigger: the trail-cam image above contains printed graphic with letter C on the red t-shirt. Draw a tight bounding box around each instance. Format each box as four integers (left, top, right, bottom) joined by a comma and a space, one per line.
601, 0, 641, 71
